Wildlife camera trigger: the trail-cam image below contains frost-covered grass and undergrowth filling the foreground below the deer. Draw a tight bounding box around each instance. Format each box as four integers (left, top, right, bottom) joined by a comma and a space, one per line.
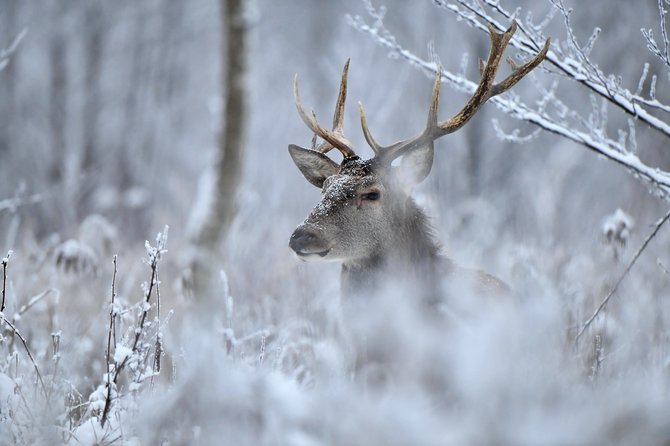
0, 204, 670, 445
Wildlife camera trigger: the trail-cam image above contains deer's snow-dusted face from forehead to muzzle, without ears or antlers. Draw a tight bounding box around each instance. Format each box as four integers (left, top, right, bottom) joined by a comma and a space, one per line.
289, 159, 407, 263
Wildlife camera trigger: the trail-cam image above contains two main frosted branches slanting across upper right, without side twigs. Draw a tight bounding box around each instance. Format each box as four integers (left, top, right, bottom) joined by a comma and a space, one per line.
348, 0, 670, 200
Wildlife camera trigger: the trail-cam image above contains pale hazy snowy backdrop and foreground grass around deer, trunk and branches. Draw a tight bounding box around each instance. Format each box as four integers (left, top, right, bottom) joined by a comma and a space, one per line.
0, 0, 670, 446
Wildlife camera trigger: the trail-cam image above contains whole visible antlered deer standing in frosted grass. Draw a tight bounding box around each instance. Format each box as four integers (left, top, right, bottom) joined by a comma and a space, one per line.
288, 22, 549, 300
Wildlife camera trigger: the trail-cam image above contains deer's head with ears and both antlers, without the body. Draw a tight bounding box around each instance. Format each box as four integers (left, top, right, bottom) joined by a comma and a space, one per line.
289, 22, 549, 266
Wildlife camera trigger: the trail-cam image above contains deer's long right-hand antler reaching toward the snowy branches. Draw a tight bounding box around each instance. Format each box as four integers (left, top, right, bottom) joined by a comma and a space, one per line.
360, 21, 550, 163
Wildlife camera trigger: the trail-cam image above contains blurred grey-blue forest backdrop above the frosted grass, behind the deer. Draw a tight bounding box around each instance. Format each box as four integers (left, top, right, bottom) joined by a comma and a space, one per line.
0, 0, 668, 271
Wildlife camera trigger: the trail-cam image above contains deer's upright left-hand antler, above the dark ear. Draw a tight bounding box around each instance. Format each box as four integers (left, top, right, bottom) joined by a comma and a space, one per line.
293, 60, 356, 158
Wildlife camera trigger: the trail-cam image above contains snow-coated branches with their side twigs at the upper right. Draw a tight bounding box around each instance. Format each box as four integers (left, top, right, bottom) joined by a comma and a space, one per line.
347, 0, 670, 200
